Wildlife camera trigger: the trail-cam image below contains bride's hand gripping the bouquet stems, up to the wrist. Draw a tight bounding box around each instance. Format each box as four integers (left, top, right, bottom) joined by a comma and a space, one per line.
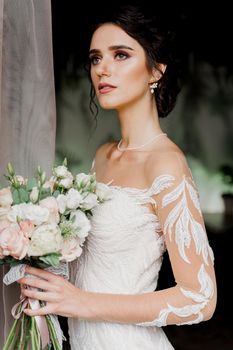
18, 266, 85, 318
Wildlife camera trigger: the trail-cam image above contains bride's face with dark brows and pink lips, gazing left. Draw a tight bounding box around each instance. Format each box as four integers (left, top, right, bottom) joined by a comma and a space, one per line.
89, 23, 152, 110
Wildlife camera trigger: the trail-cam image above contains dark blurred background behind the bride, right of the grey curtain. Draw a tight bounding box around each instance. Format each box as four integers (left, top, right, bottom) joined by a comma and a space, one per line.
52, 0, 233, 350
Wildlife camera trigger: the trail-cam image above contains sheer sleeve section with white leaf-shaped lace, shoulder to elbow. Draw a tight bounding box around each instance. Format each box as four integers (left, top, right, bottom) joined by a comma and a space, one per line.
137, 152, 216, 326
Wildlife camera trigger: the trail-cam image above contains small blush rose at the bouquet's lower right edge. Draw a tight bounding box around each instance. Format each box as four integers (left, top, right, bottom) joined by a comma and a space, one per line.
60, 237, 82, 262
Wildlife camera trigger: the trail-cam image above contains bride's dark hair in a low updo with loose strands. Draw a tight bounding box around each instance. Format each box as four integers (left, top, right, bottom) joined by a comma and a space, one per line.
88, 5, 180, 118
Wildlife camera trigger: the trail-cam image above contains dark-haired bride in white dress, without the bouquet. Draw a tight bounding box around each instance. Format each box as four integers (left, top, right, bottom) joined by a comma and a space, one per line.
19, 6, 216, 350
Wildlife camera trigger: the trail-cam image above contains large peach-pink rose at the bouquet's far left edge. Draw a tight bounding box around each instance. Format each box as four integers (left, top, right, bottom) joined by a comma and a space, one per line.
0, 225, 29, 260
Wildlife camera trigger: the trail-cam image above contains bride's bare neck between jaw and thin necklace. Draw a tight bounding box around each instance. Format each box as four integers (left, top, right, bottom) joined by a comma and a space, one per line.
118, 98, 162, 147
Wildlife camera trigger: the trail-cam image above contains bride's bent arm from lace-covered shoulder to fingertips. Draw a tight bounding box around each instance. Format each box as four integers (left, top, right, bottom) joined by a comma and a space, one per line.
20, 153, 216, 326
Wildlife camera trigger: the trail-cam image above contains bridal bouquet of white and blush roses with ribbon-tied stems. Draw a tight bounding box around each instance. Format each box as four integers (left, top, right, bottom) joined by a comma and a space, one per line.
0, 160, 109, 350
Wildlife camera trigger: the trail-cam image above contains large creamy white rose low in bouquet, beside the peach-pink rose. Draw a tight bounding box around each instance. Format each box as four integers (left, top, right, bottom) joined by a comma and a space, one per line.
28, 224, 63, 256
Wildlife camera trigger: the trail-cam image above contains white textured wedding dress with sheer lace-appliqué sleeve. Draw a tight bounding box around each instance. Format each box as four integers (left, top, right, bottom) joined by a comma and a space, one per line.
69, 153, 214, 350
